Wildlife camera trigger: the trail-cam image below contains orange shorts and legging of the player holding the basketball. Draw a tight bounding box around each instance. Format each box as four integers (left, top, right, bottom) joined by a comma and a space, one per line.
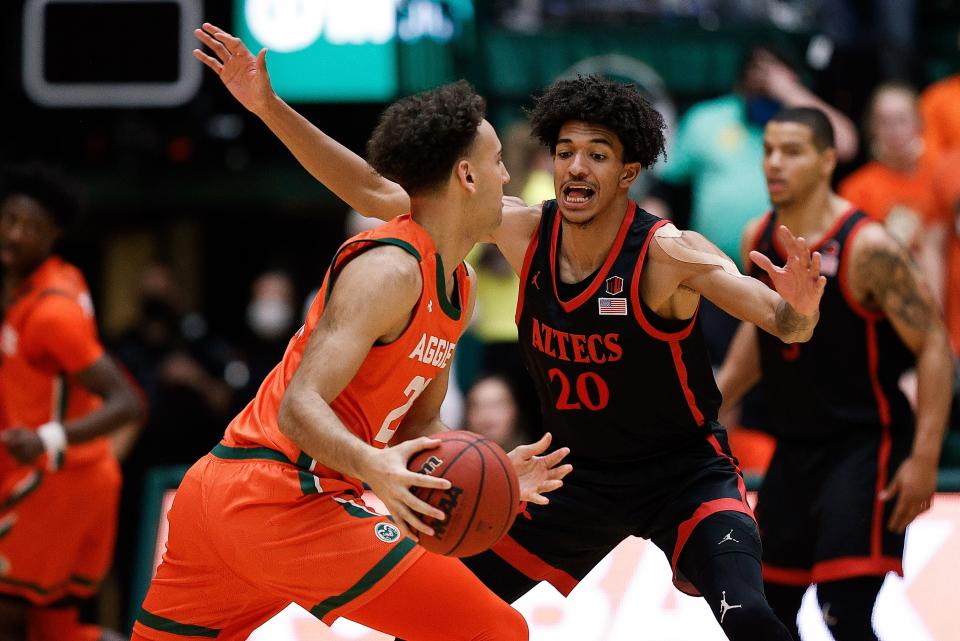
133, 448, 526, 641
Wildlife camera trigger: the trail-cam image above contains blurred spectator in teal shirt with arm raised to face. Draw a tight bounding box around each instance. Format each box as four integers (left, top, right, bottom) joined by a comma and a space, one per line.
644, 46, 858, 363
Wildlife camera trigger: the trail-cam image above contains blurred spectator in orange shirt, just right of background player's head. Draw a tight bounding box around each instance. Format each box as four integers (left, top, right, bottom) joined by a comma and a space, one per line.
839, 83, 940, 270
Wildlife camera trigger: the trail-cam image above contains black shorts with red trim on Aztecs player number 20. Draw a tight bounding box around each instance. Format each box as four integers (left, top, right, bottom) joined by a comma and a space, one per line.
484, 423, 761, 600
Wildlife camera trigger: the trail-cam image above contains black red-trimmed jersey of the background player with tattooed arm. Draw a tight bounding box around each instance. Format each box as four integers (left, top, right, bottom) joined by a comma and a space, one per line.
752, 208, 915, 439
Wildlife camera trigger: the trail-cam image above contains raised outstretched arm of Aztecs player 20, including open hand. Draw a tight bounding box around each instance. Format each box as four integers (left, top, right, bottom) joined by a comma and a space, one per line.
193, 22, 410, 220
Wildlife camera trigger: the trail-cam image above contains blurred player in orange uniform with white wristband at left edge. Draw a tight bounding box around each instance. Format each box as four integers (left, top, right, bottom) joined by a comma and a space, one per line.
0, 167, 142, 641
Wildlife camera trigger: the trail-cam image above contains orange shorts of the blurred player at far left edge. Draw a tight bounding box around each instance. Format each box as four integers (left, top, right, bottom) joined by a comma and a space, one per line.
0, 456, 120, 606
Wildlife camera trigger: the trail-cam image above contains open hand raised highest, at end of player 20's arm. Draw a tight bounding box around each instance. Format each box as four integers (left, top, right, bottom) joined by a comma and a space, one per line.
193, 22, 274, 114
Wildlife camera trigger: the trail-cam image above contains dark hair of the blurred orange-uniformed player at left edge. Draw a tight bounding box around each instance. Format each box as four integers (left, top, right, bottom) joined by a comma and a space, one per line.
0, 163, 80, 228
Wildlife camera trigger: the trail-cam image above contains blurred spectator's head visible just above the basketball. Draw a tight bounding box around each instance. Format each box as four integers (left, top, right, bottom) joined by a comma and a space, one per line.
464, 374, 525, 452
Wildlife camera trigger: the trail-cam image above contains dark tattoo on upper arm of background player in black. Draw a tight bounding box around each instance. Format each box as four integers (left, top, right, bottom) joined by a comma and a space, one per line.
857, 247, 933, 331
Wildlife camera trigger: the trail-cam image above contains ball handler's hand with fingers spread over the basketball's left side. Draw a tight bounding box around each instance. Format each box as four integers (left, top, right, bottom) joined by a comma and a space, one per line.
361, 436, 450, 539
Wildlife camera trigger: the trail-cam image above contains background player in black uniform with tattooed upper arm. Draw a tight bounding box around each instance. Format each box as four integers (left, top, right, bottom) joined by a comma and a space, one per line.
717, 108, 952, 641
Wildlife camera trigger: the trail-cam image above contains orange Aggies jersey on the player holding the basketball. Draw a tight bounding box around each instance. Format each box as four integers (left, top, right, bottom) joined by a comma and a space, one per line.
221, 214, 470, 493
